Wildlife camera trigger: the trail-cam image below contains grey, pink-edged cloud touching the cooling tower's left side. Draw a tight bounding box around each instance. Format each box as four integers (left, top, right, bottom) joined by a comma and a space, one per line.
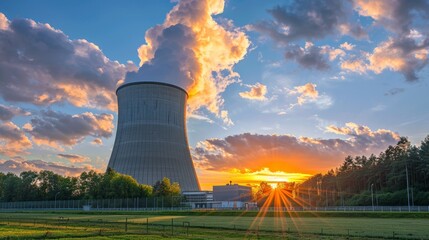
24, 110, 114, 149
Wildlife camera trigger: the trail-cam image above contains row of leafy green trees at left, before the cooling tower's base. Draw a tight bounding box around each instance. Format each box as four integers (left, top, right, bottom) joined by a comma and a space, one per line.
0, 168, 181, 202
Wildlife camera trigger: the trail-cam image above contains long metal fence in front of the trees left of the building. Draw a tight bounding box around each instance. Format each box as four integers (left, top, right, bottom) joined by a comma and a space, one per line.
0, 197, 189, 211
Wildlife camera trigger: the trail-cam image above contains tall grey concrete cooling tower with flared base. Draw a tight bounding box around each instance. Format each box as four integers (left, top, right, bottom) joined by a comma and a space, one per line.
109, 82, 200, 191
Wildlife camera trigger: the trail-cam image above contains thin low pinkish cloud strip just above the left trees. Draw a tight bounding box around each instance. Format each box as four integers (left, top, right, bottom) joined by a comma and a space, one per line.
0, 159, 99, 176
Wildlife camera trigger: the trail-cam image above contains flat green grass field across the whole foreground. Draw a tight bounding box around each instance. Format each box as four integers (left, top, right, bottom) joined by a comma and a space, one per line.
0, 211, 429, 239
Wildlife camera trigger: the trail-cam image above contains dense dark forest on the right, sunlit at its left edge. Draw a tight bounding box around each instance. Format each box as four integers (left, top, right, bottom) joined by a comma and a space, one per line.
295, 135, 429, 206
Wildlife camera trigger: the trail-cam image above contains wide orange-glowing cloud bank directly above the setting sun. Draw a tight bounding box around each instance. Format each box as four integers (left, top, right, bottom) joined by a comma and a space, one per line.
192, 123, 399, 173
